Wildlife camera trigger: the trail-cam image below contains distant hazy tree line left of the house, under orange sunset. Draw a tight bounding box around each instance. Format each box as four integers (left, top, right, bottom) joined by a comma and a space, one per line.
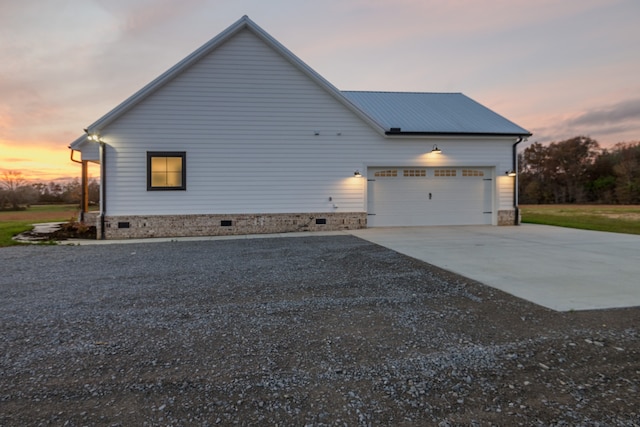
0, 171, 100, 210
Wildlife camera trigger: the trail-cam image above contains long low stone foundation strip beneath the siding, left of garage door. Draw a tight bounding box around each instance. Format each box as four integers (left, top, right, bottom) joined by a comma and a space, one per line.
96, 212, 367, 239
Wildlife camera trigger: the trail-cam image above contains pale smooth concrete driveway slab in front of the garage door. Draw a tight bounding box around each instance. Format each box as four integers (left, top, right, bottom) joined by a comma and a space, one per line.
349, 224, 640, 311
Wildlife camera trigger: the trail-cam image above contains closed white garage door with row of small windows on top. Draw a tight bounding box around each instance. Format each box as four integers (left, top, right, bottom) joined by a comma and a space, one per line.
367, 167, 493, 227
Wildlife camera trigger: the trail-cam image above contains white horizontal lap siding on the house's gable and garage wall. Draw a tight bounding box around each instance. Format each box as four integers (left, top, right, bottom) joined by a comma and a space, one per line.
102, 30, 512, 215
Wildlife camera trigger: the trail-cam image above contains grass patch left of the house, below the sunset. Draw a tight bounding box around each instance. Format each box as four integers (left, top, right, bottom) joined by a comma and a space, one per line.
0, 205, 80, 247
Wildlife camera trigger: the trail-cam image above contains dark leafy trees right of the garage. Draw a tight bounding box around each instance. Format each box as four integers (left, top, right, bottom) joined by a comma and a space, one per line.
518, 136, 640, 204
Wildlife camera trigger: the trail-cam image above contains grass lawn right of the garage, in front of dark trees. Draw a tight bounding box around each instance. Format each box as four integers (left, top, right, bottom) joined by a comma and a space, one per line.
520, 205, 640, 234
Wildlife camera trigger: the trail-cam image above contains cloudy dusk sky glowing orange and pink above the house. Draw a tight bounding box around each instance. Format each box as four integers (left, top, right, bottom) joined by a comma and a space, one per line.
0, 0, 640, 181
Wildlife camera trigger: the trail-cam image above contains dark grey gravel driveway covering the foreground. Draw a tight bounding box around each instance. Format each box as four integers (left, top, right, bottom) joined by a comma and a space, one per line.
0, 236, 640, 426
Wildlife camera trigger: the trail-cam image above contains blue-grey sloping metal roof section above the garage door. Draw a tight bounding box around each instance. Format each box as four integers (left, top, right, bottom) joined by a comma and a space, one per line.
342, 91, 531, 136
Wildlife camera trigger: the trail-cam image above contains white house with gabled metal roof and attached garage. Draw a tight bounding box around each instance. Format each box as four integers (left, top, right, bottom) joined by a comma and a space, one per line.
70, 16, 531, 239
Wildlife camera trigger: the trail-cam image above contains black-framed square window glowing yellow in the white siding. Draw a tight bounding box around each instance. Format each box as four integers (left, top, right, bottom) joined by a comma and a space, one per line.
147, 151, 187, 191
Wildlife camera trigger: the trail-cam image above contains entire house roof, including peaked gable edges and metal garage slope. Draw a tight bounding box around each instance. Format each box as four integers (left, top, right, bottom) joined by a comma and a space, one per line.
69, 15, 531, 149
